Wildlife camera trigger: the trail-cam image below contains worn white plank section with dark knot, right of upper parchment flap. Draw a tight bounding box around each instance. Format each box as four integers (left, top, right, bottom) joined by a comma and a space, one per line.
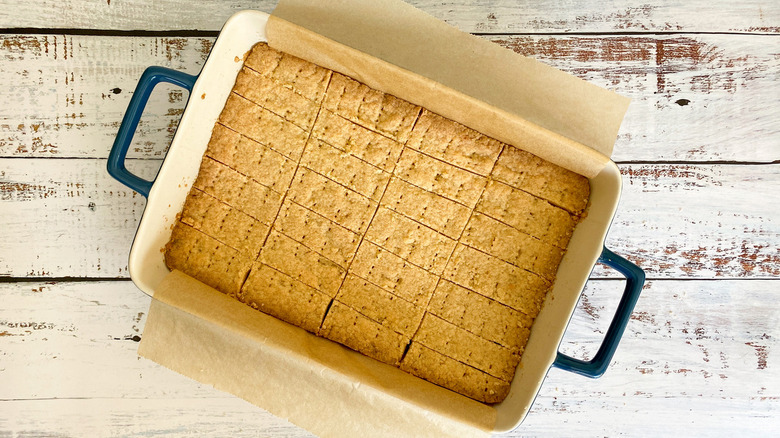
491, 35, 780, 162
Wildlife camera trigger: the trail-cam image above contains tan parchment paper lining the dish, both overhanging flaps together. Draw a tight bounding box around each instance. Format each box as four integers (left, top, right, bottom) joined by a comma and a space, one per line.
139, 0, 628, 438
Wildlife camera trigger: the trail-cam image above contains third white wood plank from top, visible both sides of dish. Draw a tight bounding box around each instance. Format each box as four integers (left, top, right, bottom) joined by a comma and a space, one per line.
0, 158, 780, 278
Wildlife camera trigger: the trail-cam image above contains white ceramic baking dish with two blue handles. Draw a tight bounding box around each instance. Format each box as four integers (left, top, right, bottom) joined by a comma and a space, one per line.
108, 11, 644, 432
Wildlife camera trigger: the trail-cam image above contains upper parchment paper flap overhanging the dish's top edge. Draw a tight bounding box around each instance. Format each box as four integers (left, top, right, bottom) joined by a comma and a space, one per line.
267, 0, 629, 178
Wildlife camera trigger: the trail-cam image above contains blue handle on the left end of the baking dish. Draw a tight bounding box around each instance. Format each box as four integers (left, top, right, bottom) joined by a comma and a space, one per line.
107, 67, 198, 197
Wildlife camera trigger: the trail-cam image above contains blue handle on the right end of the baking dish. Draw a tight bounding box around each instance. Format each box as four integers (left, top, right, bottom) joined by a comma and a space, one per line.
553, 247, 645, 379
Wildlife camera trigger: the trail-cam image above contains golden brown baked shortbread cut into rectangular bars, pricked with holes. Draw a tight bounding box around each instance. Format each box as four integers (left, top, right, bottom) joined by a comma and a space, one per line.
165, 43, 590, 403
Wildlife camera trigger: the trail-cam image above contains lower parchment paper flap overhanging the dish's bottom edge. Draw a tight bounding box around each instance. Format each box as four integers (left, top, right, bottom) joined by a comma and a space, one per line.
138, 271, 495, 438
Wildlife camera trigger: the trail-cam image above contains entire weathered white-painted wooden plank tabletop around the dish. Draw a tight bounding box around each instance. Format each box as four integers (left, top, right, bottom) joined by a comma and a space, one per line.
0, 0, 780, 437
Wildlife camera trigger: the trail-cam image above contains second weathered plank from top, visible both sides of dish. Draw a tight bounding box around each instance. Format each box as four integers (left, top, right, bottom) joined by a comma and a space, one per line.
0, 35, 780, 162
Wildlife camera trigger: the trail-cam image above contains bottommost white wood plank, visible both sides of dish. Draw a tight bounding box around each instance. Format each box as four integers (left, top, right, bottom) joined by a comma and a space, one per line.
0, 280, 780, 437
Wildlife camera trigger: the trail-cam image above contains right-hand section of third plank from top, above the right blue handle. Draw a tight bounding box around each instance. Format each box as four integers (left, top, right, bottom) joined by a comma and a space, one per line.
595, 165, 780, 278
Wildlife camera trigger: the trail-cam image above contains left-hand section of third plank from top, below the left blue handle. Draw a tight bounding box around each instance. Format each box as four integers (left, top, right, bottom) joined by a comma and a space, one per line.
0, 158, 160, 278
